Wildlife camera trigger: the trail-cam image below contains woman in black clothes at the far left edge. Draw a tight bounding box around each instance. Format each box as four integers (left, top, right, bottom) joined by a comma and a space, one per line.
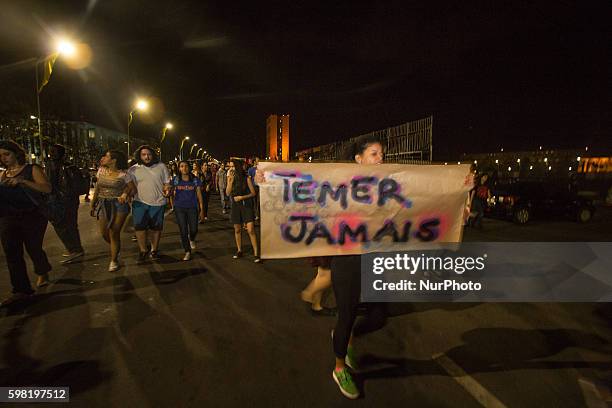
0, 140, 51, 306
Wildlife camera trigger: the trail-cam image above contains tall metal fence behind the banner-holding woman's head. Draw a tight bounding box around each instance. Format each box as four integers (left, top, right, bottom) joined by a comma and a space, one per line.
295, 116, 433, 164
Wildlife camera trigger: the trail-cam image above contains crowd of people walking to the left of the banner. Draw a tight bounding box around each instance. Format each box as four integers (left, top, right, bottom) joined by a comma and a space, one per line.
0, 140, 261, 306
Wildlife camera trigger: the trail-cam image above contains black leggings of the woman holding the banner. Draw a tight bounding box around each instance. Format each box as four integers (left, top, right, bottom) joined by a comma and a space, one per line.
331, 255, 386, 359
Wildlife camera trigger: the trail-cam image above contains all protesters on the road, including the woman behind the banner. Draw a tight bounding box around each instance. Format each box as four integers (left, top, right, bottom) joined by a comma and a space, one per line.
0, 139, 440, 399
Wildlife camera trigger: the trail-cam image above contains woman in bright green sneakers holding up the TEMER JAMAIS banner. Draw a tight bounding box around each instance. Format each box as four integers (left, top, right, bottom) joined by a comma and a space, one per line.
331, 137, 383, 399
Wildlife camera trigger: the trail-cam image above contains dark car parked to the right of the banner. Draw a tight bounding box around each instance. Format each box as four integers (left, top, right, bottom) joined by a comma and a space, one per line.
487, 181, 595, 224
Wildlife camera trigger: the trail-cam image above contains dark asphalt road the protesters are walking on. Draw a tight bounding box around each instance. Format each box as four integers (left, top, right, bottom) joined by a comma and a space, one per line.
0, 197, 612, 407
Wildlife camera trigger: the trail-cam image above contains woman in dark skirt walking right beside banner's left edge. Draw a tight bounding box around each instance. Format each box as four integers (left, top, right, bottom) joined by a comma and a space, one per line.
225, 159, 261, 263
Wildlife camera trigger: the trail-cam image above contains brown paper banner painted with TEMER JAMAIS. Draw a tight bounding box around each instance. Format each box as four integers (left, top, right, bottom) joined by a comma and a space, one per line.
256, 162, 473, 258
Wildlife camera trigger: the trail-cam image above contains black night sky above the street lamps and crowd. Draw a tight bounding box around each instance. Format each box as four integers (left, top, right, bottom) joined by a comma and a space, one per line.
0, 0, 612, 160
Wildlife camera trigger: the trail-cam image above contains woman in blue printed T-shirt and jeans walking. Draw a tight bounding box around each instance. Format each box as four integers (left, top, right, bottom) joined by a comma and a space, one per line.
172, 160, 205, 261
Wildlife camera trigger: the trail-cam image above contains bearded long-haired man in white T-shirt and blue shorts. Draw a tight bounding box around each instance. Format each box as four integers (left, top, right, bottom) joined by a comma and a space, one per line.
128, 145, 171, 262
